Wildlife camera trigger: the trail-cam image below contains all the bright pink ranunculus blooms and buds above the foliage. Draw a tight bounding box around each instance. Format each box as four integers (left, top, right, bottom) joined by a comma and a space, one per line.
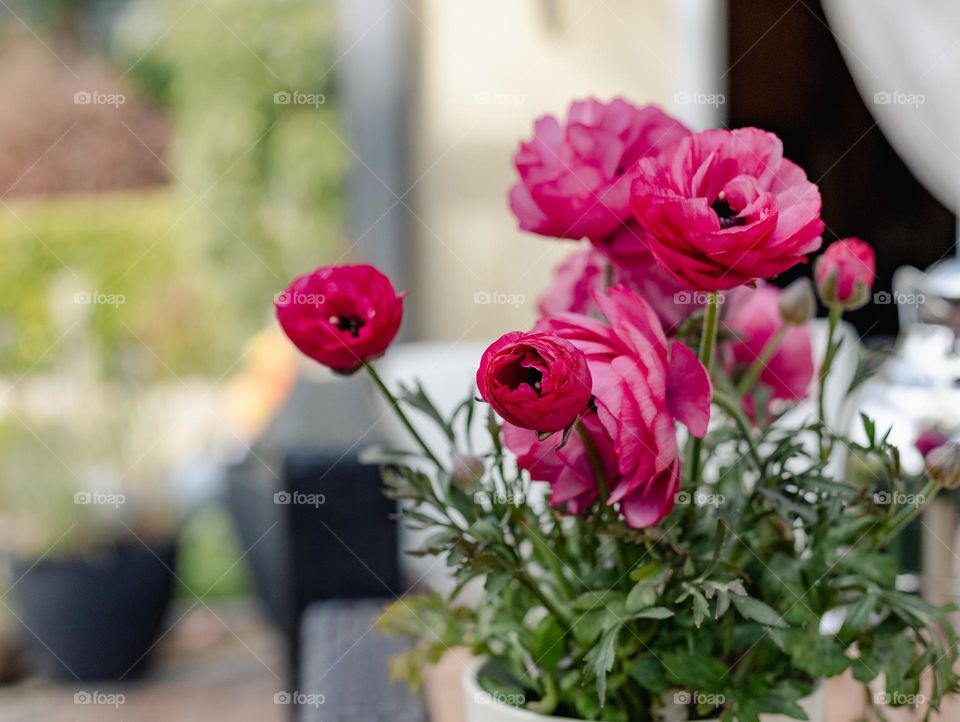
276, 94, 874, 528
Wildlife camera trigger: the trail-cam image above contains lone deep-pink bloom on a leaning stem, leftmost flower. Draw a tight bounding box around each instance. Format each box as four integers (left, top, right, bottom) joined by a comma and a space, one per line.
274, 265, 403, 374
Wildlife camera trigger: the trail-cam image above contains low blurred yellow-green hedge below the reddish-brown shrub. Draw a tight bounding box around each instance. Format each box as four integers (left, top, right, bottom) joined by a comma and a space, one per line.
0, 190, 247, 381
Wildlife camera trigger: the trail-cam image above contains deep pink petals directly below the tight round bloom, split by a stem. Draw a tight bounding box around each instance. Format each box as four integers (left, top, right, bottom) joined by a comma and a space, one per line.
503, 411, 620, 515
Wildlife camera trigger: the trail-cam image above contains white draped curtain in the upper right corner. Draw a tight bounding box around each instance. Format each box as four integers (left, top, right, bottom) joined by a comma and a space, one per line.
824, 0, 960, 212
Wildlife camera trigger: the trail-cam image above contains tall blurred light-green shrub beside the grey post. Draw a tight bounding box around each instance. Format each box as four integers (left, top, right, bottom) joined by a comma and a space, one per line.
113, 0, 348, 331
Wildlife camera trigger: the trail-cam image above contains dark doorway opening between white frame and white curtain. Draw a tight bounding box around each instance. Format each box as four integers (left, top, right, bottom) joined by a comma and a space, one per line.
726, 0, 956, 335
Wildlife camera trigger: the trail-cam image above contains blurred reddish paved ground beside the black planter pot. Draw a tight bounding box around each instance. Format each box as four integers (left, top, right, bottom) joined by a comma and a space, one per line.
0, 603, 291, 722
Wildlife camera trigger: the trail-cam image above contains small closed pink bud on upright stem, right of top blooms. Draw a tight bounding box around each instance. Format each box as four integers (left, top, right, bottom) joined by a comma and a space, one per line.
813, 233, 877, 310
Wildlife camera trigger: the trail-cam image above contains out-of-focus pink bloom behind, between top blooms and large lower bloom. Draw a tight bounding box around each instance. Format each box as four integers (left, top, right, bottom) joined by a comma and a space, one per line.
539, 232, 688, 332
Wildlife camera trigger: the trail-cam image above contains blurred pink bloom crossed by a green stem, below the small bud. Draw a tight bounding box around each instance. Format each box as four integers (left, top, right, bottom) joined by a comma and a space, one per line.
722, 284, 814, 408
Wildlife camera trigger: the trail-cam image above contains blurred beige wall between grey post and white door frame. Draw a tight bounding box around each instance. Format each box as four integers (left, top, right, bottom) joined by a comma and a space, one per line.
411, 0, 676, 339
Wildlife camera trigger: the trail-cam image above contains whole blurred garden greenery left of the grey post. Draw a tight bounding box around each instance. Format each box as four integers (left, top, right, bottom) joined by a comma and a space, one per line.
0, 0, 347, 596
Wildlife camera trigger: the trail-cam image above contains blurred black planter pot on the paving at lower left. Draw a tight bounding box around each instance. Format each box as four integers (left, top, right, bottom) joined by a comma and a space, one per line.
13, 541, 176, 681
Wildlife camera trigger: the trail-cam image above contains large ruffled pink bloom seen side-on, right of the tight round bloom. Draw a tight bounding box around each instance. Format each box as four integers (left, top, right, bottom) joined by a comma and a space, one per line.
536, 286, 712, 528
